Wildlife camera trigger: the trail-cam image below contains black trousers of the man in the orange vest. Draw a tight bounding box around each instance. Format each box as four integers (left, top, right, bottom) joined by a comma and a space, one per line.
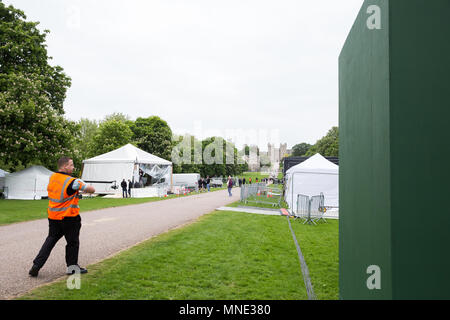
33, 215, 81, 269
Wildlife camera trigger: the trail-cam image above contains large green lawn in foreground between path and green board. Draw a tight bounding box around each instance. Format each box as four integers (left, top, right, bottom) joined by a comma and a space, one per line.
21, 211, 338, 300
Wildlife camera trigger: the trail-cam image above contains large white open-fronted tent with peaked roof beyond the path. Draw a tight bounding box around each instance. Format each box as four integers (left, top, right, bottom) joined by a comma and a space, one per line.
81, 144, 172, 197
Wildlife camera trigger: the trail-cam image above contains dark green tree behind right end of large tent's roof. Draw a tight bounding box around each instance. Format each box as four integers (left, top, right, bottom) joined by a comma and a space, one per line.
130, 116, 172, 160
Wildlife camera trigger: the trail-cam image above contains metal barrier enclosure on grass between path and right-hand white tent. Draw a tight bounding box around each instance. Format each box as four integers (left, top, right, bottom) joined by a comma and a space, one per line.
241, 183, 283, 207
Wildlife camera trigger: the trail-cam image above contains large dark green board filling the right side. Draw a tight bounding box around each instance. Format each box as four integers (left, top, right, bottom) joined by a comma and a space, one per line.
339, 0, 450, 299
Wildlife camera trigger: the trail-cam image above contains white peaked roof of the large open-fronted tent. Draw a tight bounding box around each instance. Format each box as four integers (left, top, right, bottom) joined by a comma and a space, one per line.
83, 144, 172, 165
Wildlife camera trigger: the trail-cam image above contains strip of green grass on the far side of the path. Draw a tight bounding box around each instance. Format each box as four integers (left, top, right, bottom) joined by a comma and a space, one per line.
0, 188, 225, 225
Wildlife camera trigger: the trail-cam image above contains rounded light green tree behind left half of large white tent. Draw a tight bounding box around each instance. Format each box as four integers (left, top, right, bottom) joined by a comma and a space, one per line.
90, 119, 133, 155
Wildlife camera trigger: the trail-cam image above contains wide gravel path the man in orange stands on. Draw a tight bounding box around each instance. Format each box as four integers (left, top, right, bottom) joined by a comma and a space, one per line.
0, 188, 239, 299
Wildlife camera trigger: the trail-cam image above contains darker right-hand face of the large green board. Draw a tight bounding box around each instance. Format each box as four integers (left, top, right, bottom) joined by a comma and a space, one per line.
390, 0, 450, 299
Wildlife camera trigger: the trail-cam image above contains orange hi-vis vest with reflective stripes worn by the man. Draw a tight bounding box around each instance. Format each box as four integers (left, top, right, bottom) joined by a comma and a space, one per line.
47, 172, 86, 220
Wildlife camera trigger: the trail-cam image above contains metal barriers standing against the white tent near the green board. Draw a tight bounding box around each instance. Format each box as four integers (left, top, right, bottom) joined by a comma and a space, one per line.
293, 193, 327, 224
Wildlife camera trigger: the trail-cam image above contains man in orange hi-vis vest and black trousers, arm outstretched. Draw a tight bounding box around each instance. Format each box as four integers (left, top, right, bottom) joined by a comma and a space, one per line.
29, 157, 95, 277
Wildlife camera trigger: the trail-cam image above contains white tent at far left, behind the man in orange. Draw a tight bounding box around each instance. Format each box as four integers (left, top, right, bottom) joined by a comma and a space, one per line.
5, 166, 53, 200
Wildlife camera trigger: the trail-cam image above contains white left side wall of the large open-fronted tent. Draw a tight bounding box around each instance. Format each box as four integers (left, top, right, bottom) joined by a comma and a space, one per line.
81, 162, 134, 193
